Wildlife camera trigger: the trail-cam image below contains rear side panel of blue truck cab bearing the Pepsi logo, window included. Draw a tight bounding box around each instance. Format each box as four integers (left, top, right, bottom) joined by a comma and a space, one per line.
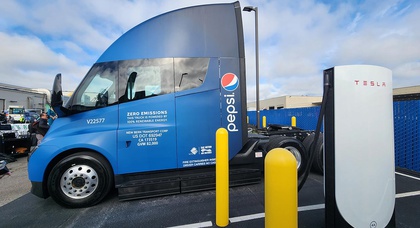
174, 58, 246, 168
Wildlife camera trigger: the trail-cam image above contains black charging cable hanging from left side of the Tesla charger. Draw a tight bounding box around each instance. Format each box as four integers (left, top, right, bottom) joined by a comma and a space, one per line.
298, 73, 331, 191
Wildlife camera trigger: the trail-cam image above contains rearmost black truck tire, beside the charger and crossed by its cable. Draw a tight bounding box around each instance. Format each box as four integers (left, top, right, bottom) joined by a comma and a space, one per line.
303, 133, 324, 174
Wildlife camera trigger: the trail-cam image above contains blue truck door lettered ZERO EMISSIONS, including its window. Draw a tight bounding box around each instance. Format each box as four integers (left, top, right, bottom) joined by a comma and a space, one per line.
117, 58, 177, 174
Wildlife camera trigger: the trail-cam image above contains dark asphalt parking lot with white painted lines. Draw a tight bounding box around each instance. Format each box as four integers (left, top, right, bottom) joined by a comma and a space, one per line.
0, 157, 420, 228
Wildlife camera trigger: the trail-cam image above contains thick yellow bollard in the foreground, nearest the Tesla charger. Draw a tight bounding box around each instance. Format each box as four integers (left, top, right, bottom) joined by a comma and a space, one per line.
264, 148, 298, 228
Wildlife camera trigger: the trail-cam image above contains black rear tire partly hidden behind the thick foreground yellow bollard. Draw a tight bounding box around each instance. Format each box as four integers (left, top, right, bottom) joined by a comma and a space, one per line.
266, 135, 308, 177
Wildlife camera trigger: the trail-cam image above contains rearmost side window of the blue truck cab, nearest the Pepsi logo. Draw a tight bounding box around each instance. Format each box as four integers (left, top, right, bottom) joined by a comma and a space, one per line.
174, 58, 210, 92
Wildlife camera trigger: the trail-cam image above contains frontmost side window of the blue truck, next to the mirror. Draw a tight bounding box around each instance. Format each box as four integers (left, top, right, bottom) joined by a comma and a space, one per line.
66, 62, 118, 112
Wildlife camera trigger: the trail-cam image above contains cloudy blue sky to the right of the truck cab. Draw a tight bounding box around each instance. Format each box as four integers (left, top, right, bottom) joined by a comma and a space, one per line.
244, 1, 420, 100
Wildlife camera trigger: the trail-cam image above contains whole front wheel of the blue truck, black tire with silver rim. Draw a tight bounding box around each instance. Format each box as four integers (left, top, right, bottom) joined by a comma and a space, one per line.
48, 152, 113, 208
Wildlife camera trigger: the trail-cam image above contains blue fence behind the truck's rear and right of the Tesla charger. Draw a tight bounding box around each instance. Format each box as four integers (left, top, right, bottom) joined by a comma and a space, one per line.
248, 100, 420, 172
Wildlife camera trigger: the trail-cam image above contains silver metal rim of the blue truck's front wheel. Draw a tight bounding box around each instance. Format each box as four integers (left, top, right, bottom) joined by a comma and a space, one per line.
60, 165, 99, 199
